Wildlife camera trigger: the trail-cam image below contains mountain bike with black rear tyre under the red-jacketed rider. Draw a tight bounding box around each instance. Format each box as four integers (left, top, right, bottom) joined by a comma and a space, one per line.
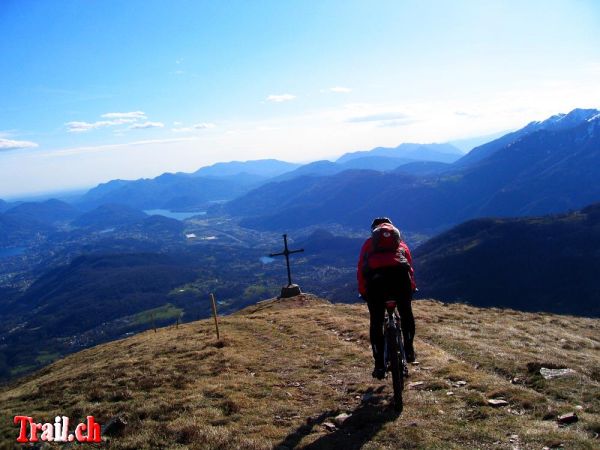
383, 300, 408, 411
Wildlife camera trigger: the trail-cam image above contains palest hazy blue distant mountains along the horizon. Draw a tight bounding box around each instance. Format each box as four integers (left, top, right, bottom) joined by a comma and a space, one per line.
69, 144, 462, 211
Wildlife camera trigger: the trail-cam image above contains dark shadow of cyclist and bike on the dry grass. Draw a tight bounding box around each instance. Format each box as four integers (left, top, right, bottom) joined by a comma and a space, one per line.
274, 386, 402, 450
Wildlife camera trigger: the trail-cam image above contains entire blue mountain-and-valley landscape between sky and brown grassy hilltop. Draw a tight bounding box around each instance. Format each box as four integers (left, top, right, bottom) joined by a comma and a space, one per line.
0, 106, 600, 384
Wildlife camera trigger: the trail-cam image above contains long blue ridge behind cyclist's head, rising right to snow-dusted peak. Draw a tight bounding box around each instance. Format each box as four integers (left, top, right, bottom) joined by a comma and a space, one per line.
223, 110, 600, 233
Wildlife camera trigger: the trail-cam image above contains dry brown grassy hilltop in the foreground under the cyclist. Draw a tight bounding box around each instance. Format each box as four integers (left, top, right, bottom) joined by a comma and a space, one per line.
0, 296, 600, 450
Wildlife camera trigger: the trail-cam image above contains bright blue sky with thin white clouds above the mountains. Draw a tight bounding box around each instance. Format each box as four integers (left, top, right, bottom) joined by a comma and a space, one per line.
0, 0, 600, 199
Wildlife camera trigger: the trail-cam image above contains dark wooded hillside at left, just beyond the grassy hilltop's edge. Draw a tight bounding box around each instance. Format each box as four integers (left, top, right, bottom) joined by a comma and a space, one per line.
0, 253, 196, 382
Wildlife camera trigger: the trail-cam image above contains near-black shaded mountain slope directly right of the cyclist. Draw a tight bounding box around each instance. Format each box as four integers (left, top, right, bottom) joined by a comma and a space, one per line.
414, 204, 600, 317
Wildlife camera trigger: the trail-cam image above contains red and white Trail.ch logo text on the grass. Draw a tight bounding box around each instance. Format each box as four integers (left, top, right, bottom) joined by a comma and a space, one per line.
13, 416, 102, 443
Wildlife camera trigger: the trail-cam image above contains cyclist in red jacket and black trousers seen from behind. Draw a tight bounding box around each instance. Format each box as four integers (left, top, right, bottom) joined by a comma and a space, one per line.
356, 217, 416, 380
